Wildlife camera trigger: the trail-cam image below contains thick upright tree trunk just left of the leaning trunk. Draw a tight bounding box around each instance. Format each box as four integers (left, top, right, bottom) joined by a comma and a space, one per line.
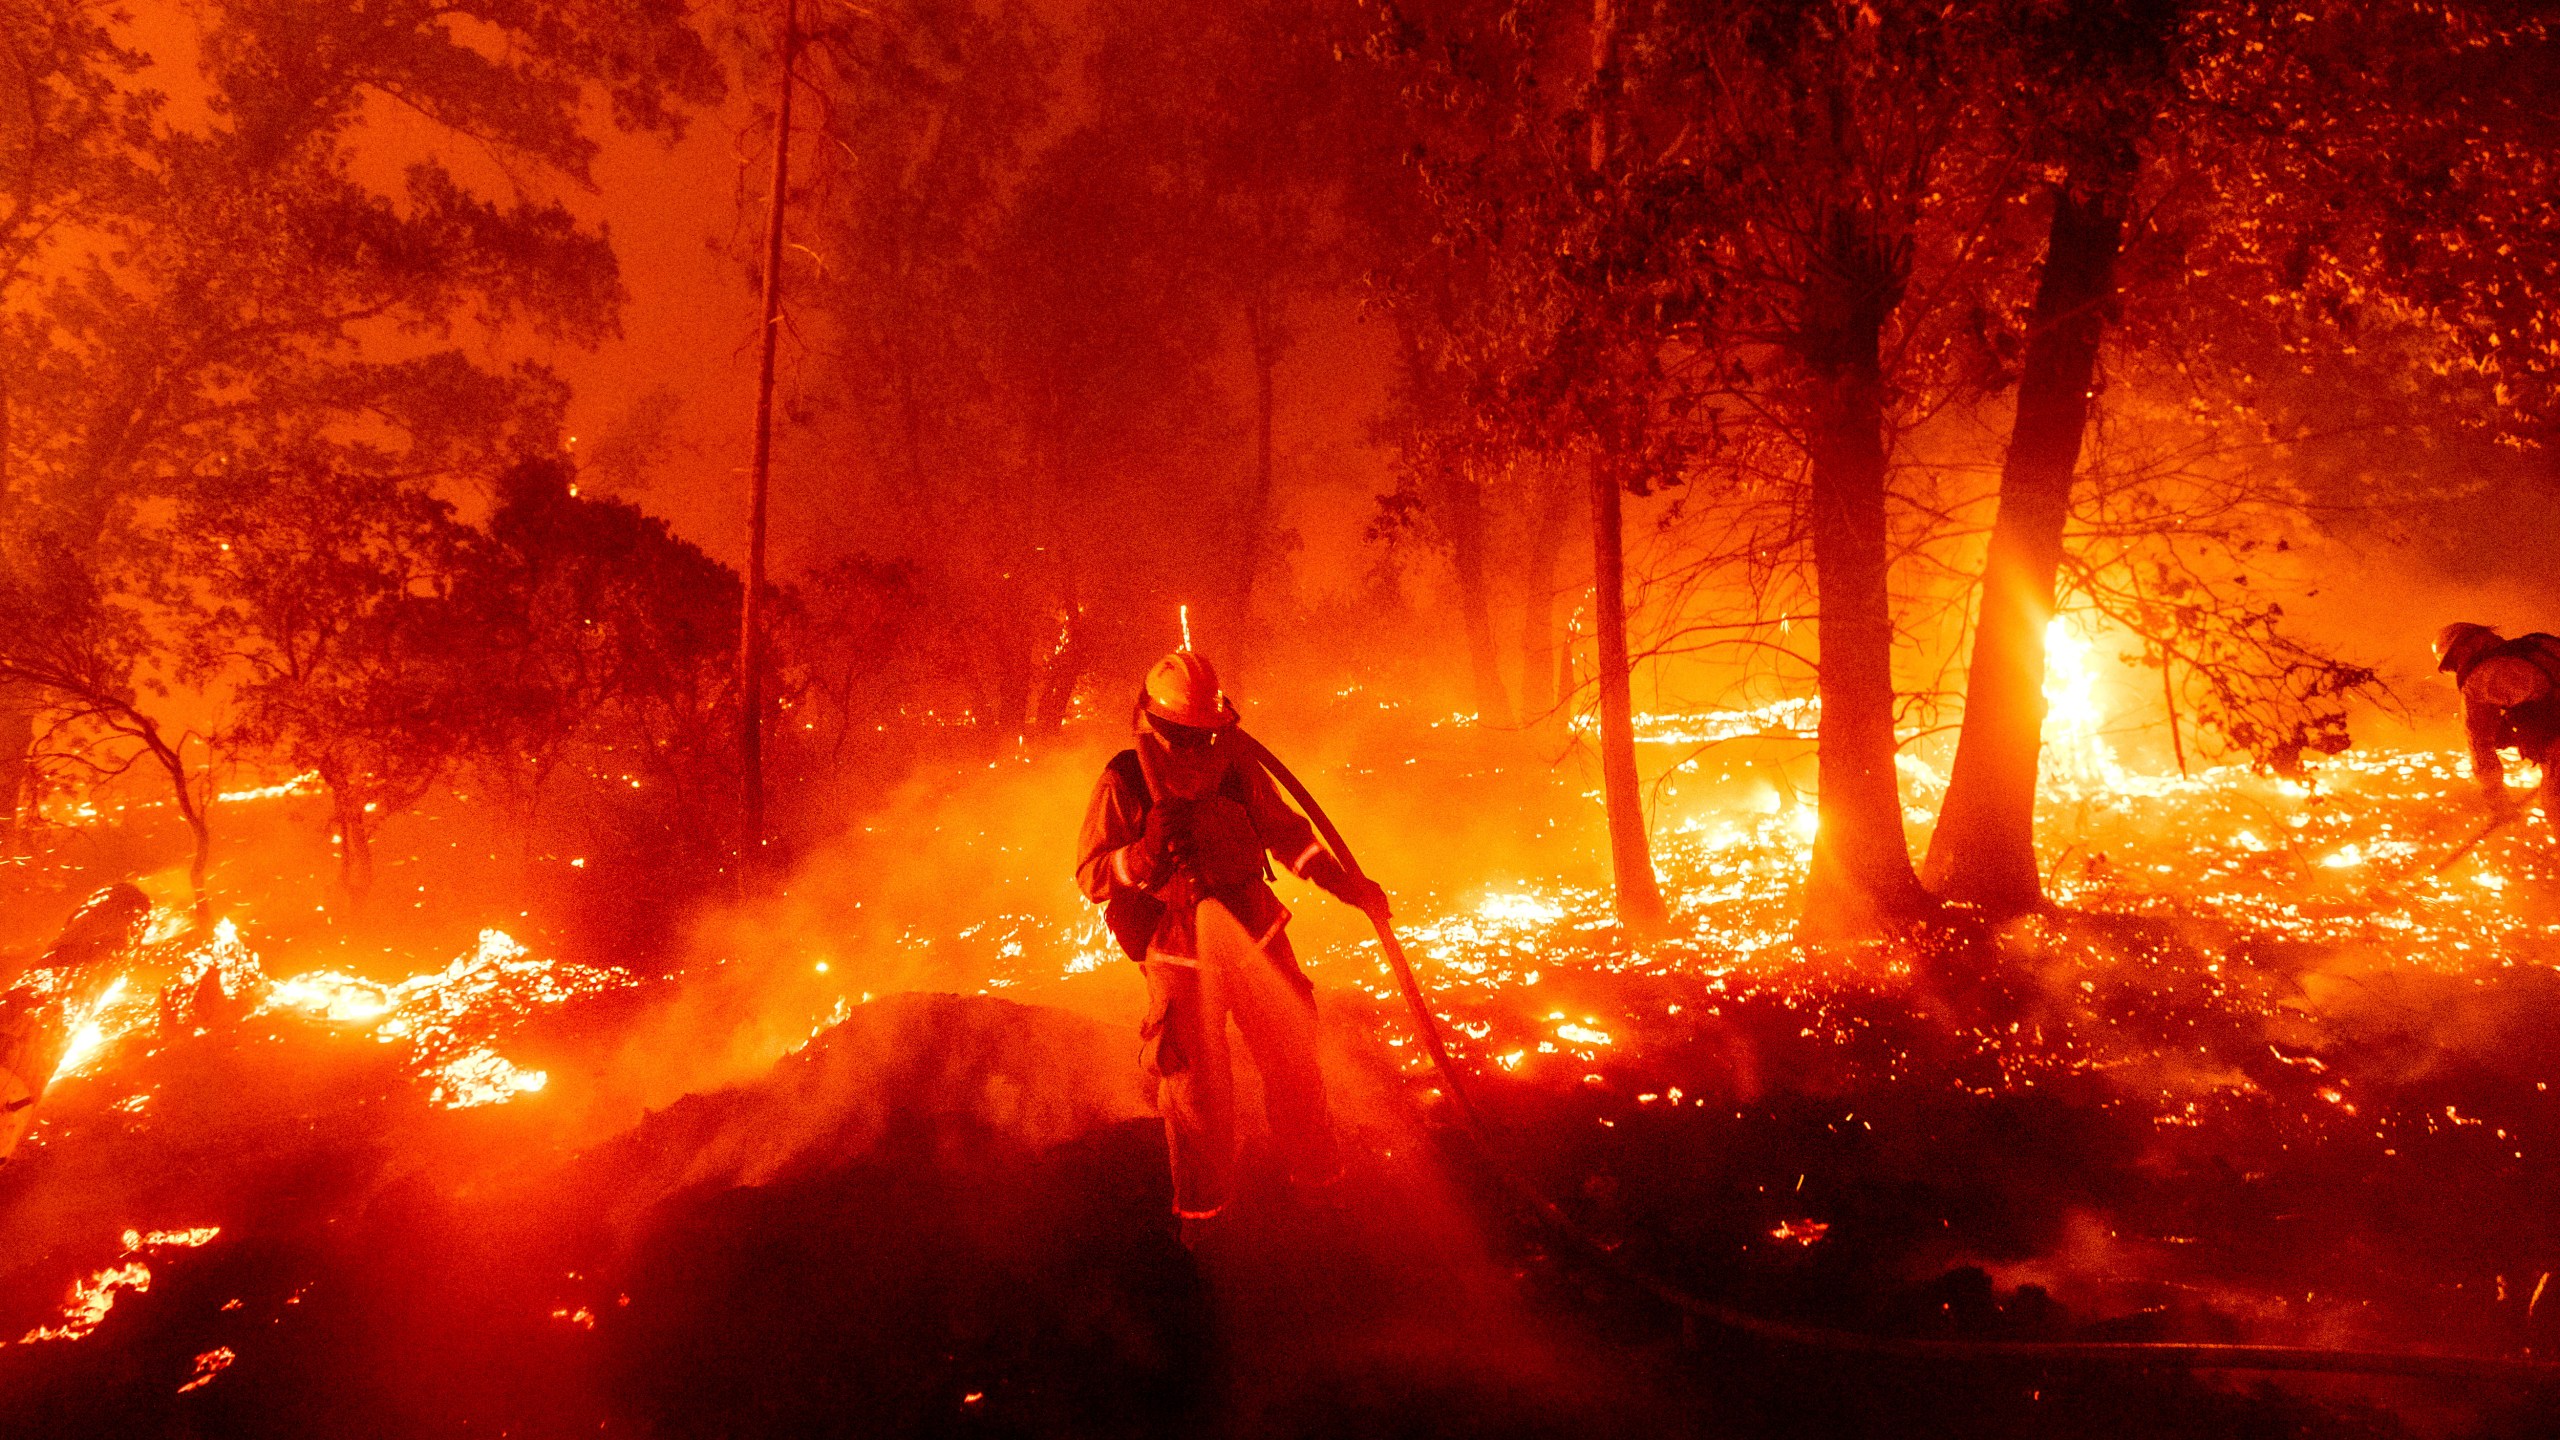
1805, 208, 1930, 940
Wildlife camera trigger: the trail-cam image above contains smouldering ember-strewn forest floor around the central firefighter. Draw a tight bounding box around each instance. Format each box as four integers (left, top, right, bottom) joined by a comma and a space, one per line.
0, 720, 2560, 1435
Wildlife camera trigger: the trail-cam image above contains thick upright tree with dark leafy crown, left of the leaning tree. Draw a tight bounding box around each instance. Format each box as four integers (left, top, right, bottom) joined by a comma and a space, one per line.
1626, 5, 2010, 938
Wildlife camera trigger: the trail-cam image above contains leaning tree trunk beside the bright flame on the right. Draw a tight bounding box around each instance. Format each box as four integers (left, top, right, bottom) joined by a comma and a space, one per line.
1925, 182, 2122, 917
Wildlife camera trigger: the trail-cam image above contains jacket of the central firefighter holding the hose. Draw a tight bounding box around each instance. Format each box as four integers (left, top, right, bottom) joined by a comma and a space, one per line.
1075, 735, 1341, 961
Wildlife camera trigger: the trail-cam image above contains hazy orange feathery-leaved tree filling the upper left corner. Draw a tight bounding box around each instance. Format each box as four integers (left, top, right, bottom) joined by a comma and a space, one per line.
0, 0, 719, 891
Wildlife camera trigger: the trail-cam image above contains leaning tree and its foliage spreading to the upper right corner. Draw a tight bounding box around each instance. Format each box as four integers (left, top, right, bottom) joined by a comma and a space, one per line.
1928, 3, 2560, 915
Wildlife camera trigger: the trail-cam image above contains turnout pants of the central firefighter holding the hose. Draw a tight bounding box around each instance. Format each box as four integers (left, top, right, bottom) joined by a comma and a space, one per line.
1139, 899, 1334, 1220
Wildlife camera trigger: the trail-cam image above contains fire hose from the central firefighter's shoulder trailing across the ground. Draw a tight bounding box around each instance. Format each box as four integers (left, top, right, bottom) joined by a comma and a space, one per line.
1231, 728, 2560, 1381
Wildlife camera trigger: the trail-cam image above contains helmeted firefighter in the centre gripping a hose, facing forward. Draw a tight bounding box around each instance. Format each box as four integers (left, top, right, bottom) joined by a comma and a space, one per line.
1075, 651, 1388, 1243
